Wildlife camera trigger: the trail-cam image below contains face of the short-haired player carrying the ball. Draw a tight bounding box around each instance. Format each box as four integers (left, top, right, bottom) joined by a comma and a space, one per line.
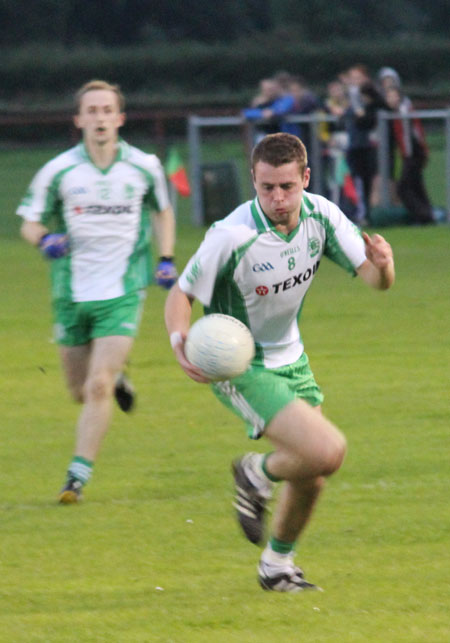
253, 161, 310, 232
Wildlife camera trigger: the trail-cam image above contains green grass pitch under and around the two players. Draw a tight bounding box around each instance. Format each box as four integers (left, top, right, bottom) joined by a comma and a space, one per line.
0, 150, 450, 643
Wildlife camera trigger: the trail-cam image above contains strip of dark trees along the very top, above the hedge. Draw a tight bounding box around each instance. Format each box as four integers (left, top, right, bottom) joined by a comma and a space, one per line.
0, 0, 448, 47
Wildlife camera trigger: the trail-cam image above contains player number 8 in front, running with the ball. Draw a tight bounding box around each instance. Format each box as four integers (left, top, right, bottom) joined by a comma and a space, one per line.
165, 133, 394, 592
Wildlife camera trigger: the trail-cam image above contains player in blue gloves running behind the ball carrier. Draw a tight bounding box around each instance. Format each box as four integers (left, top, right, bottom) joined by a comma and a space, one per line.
17, 80, 177, 504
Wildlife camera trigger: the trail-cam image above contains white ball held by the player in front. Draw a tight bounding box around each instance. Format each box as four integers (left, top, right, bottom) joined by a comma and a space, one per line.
184, 313, 255, 381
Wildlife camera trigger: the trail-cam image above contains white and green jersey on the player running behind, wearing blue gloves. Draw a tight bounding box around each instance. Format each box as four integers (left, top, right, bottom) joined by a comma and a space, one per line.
17, 141, 169, 302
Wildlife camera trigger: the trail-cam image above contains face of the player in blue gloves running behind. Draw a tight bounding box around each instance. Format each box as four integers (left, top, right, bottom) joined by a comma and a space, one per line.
74, 89, 125, 145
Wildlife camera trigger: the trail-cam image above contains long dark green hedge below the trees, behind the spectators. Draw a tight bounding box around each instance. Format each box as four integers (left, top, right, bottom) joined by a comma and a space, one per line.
0, 31, 450, 109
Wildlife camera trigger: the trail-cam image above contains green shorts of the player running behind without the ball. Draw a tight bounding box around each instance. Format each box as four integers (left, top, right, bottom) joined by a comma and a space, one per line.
53, 291, 145, 346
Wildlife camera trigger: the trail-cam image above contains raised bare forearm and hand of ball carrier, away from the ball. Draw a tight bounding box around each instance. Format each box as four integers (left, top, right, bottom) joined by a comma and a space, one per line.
356, 232, 395, 290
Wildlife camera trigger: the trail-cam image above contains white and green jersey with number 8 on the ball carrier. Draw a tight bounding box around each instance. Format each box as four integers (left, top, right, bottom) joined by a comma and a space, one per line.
179, 192, 366, 368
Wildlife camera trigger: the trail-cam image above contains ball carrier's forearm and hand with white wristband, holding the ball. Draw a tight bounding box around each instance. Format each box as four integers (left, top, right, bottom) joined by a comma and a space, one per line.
164, 283, 210, 384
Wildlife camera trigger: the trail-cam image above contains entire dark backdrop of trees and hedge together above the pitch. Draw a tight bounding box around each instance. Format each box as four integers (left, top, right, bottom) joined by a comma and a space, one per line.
0, 0, 450, 111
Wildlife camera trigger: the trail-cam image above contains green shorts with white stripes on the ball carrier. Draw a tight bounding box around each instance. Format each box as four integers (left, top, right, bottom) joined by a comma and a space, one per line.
212, 353, 323, 440
